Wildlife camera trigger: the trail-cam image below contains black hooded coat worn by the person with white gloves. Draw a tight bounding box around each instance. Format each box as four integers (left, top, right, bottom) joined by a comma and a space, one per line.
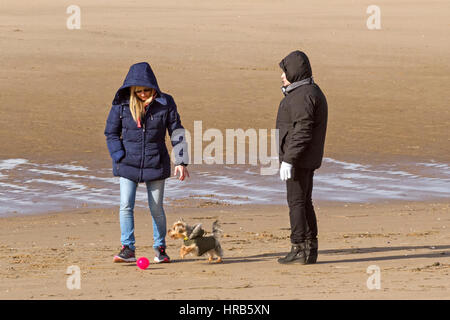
276, 51, 328, 169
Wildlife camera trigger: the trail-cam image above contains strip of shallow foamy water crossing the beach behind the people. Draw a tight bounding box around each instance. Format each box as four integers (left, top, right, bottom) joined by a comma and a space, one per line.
0, 158, 450, 216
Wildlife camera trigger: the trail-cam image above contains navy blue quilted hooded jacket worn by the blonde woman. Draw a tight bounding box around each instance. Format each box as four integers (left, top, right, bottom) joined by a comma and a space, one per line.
105, 62, 188, 183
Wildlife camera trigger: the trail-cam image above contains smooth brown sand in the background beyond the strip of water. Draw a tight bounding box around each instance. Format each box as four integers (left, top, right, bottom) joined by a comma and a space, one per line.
0, 0, 450, 168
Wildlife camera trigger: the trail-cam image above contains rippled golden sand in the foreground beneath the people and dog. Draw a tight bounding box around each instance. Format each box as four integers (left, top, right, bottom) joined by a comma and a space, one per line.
0, 201, 450, 299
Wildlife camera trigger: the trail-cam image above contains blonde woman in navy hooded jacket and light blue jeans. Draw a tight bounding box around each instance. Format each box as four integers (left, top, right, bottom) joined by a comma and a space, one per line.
105, 62, 189, 263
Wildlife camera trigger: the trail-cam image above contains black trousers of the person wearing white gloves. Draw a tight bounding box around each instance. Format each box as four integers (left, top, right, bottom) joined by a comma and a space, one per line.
286, 168, 317, 244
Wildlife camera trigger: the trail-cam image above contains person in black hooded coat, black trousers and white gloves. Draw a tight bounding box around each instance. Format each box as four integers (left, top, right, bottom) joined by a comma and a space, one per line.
276, 51, 328, 264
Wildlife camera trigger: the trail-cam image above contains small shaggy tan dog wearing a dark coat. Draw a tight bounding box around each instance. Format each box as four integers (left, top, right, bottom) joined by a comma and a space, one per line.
168, 219, 223, 263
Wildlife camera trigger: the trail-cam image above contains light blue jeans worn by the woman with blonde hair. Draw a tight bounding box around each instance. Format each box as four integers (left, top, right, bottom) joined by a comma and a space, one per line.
120, 177, 167, 250
